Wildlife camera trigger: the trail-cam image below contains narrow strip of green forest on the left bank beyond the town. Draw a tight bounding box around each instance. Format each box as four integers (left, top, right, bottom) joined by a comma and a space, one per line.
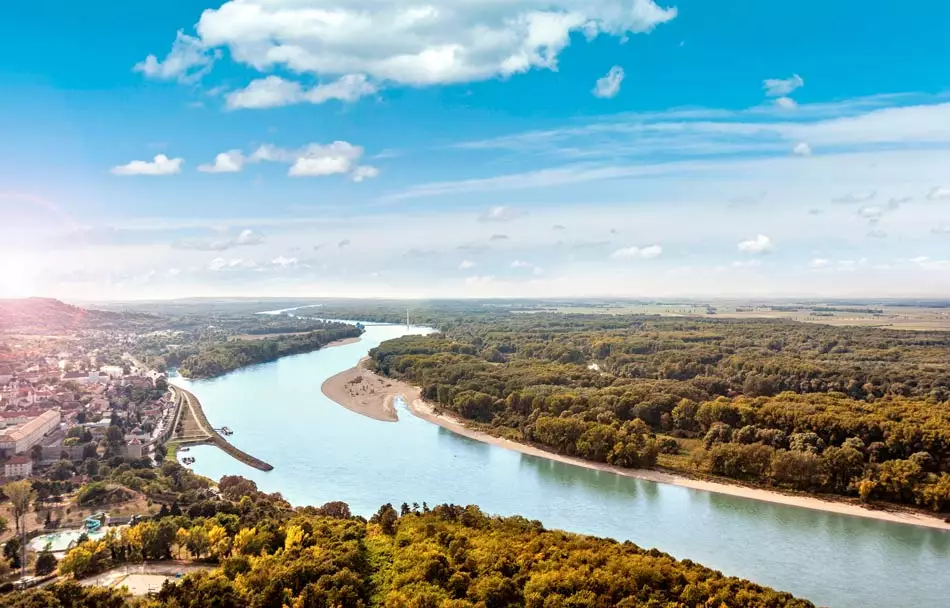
180, 323, 363, 378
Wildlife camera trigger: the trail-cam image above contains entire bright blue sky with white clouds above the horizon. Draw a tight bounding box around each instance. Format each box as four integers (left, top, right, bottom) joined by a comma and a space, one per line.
0, 0, 950, 298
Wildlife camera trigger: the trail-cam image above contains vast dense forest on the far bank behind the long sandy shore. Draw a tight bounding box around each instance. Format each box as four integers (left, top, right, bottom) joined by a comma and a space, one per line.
371, 314, 950, 511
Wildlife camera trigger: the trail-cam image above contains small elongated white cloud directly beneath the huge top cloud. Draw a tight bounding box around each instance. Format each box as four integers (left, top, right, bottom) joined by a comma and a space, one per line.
225, 74, 377, 110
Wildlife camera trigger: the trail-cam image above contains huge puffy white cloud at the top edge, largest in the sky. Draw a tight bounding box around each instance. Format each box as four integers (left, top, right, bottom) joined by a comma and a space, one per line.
146, 0, 677, 86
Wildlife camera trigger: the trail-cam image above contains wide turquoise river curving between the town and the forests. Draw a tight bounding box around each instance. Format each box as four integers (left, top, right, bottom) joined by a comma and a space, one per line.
173, 326, 950, 608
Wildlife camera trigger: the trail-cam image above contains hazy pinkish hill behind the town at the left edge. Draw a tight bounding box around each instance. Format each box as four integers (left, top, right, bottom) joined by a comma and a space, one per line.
0, 298, 121, 333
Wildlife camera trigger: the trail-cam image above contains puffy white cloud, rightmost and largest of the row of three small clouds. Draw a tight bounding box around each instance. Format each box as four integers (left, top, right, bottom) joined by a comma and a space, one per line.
248, 141, 379, 182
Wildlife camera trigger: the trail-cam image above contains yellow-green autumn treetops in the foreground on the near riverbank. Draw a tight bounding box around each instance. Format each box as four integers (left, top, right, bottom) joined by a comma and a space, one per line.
0, 477, 813, 608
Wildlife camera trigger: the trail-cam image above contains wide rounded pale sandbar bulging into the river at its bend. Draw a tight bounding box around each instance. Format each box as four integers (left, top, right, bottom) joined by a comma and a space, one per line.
322, 357, 420, 422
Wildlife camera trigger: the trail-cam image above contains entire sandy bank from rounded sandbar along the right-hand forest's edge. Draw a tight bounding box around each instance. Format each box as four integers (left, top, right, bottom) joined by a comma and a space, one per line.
323, 359, 950, 531
